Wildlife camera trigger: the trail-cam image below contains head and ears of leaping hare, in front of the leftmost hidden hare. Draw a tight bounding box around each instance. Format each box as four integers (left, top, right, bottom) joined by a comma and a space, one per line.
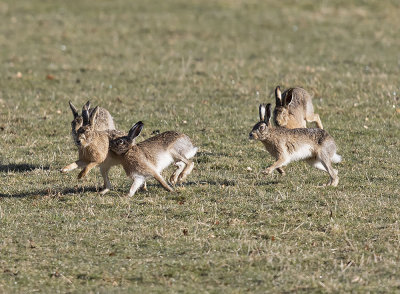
76, 103, 99, 147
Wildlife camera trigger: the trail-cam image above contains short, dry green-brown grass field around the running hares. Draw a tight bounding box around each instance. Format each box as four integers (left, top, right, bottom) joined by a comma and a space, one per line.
0, 0, 400, 293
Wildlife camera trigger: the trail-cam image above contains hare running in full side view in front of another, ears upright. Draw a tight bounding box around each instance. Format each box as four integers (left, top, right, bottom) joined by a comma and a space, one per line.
249, 104, 341, 186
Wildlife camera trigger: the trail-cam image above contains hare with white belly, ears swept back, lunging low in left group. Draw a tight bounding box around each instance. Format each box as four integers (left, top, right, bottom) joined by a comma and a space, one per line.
110, 121, 197, 196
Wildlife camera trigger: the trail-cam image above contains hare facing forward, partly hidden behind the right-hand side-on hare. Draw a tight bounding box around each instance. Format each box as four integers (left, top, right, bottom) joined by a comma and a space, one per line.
274, 86, 323, 129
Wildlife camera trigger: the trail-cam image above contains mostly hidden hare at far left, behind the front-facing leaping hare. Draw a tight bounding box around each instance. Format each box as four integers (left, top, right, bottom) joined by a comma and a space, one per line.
69, 101, 115, 145
